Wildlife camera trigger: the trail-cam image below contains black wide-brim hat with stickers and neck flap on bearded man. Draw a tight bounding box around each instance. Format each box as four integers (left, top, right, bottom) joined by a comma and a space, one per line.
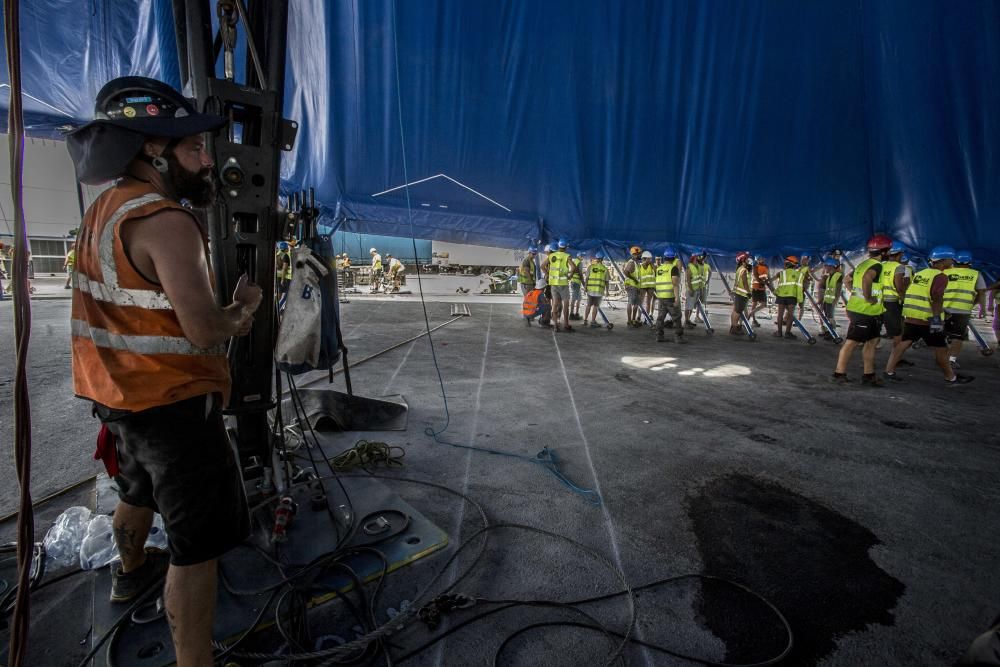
66, 76, 226, 184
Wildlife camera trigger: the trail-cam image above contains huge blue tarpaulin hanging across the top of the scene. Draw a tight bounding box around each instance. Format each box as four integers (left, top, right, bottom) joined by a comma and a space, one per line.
0, 0, 1000, 261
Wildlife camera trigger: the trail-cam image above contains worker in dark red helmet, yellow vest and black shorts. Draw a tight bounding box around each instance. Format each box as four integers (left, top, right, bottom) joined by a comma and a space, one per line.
830, 234, 892, 387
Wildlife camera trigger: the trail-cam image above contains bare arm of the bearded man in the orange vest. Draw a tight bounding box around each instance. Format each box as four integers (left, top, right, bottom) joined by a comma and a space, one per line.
123, 211, 261, 348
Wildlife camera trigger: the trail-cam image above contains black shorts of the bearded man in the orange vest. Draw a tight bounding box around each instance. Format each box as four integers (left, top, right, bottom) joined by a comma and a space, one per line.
95, 394, 250, 566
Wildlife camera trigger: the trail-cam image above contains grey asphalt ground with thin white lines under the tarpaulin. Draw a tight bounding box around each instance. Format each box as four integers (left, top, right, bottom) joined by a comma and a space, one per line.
0, 288, 1000, 665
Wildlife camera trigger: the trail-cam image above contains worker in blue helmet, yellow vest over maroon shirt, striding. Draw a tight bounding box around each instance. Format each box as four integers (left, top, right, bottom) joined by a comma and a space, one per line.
885, 246, 974, 386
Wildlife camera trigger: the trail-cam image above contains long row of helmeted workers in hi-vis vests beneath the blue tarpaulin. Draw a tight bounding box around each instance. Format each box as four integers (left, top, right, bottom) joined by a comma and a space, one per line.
517, 234, 1000, 386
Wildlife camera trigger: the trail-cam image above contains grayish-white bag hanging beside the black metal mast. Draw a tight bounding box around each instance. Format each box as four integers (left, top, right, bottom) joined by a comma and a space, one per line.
274, 246, 329, 368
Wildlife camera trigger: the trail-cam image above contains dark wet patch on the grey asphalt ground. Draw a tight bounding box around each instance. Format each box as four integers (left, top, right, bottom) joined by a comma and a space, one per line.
688, 474, 905, 665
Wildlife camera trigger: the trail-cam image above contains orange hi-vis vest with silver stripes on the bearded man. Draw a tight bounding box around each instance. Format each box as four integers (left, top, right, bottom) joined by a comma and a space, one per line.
70, 179, 231, 411
